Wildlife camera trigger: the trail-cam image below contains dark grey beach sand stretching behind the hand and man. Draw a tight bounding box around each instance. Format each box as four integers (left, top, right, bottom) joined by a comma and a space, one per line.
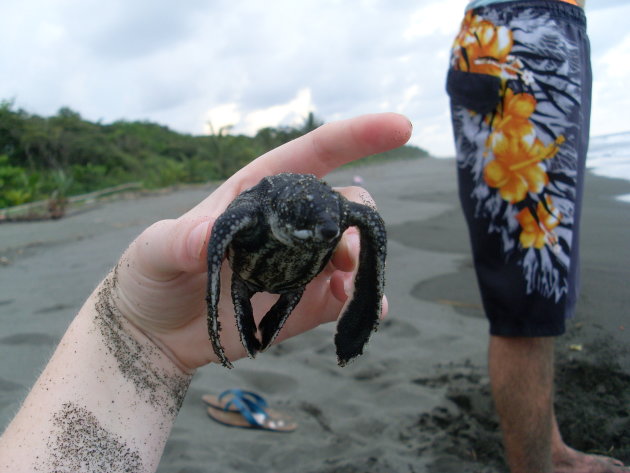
0, 159, 630, 473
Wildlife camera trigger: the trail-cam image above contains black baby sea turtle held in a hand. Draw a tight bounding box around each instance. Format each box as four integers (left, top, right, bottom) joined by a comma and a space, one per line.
206, 173, 387, 368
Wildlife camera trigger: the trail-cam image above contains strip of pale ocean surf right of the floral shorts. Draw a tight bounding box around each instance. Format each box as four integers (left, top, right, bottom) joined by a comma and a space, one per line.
586, 131, 630, 202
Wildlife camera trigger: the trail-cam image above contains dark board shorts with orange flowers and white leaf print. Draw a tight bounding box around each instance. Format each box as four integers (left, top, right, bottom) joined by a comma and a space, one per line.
447, 0, 592, 337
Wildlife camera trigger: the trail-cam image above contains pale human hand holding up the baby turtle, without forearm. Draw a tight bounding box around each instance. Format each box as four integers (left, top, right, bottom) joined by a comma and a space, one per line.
114, 114, 411, 371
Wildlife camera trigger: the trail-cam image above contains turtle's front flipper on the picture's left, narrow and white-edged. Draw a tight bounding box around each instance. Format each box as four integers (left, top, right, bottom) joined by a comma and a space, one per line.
206, 206, 255, 368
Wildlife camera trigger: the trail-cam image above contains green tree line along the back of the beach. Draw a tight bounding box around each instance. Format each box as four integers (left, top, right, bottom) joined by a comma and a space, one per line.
0, 101, 428, 208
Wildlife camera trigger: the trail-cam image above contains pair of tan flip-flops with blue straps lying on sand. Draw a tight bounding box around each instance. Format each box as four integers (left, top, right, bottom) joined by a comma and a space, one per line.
202, 389, 297, 433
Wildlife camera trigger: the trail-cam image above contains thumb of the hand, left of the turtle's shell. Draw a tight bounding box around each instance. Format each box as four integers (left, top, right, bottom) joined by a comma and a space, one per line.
129, 217, 214, 280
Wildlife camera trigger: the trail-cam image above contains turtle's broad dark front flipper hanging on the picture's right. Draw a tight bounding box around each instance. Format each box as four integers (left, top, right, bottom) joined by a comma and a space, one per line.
335, 202, 387, 366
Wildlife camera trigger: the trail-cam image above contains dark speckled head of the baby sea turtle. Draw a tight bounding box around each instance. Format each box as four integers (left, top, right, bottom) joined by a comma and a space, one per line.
269, 173, 342, 246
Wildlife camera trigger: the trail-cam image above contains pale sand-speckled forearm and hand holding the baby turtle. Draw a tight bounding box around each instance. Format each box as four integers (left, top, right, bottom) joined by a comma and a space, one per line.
0, 113, 411, 473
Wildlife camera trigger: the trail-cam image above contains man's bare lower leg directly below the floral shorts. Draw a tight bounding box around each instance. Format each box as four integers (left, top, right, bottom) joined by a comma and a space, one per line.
488, 336, 554, 473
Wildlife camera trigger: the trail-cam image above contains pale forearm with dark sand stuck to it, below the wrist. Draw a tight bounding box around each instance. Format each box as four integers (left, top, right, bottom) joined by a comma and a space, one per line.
0, 273, 191, 473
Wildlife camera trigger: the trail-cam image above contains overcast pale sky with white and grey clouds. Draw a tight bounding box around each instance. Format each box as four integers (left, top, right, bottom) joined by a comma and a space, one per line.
0, 0, 630, 156
